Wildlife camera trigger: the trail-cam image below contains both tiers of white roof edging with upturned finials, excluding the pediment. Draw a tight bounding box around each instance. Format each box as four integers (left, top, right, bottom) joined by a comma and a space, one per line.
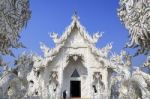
37, 14, 112, 66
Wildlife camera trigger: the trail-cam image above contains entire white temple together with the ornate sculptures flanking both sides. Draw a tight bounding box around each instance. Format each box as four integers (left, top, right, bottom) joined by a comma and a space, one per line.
0, 14, 150, 99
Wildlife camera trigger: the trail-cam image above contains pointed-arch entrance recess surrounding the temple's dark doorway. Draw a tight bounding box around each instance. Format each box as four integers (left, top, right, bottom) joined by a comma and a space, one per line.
63, 55, 88, 98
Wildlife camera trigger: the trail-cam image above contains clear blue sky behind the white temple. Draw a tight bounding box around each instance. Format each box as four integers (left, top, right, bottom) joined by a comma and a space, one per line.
6, 0, 148, 66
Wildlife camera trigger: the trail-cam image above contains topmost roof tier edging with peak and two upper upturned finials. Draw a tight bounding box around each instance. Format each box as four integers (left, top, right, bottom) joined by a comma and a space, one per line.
50, 14, 102, 44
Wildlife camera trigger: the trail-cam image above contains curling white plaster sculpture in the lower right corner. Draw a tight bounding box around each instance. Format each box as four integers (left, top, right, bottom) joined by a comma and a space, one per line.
119, 68, 150, 99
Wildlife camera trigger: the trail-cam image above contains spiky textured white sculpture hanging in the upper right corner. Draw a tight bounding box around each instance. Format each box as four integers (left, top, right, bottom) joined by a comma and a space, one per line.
118, 0, 150, 54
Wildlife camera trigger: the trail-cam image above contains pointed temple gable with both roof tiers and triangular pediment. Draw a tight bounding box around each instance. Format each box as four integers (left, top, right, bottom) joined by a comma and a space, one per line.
40, 14, 112, 66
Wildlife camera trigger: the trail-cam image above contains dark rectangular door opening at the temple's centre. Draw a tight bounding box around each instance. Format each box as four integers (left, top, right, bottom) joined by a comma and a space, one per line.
70, 81, 81, 97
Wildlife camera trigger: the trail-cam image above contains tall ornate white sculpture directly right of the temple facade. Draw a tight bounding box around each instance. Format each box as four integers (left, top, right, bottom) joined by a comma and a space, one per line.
110, 51, 132, 99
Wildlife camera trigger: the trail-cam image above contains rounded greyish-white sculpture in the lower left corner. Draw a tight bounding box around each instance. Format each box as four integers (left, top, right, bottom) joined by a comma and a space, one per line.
0, 71, 22, 99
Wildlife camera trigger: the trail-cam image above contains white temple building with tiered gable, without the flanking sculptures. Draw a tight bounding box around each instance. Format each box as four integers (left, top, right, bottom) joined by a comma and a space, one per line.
24, 14, 127, 99
